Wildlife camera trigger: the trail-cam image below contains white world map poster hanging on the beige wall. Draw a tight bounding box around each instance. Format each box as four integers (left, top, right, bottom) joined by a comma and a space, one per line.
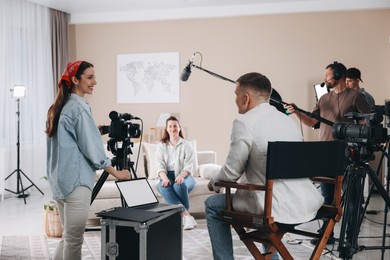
117, 52, 180, 103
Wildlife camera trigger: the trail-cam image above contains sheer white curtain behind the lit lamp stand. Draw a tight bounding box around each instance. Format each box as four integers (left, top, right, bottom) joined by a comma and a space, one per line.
0, 0, 54, 198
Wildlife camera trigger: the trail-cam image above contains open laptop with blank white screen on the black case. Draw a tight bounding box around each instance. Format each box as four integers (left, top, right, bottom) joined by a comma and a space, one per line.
115, 178, 182, 212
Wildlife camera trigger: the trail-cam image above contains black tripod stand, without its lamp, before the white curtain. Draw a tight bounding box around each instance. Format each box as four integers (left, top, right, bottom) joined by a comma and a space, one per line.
5, 99, 44, 204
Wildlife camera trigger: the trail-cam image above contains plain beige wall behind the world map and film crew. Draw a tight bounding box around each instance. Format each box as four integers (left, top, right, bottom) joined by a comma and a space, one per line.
71, 10, 390, 163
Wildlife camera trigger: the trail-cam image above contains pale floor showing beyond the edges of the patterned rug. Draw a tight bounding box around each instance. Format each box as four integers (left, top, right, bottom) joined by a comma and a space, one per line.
0, 188, 390, 259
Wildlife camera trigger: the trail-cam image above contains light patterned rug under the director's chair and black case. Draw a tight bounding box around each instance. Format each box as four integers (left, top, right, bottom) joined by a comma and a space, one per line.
0, 219, 338, 260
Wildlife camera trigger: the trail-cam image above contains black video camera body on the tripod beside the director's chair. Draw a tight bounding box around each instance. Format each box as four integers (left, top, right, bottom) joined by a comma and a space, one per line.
332, 101, 390, 145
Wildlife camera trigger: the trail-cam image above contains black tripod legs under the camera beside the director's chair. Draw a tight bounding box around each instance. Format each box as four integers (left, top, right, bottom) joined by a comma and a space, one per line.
338, 144, 390, 259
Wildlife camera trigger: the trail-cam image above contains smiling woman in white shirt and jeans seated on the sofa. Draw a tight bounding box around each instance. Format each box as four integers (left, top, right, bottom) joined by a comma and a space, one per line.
156, 116, 197, 229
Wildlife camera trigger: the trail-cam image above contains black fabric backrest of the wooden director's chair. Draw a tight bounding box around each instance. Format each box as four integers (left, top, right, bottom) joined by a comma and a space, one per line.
267, 141, 347, 179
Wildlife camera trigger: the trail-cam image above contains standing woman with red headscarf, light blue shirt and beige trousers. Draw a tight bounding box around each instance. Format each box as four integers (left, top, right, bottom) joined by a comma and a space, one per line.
45, 61, 130, 260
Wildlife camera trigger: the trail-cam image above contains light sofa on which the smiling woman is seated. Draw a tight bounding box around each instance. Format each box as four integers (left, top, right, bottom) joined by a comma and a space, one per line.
87, 141, 221, 226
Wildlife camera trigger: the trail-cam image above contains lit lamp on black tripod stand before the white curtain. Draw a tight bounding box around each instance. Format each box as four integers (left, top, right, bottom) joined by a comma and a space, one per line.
5, 86, 44, 204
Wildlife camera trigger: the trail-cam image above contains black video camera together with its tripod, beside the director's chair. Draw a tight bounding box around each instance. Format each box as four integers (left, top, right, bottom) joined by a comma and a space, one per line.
332, 101, 390, 259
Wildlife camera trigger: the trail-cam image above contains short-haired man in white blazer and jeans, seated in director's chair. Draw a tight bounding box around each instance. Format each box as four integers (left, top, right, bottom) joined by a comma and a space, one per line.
205, 73, 324, 260
